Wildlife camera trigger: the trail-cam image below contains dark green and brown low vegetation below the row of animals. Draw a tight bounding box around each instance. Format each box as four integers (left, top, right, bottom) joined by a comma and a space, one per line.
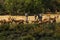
0, 23, 60, 40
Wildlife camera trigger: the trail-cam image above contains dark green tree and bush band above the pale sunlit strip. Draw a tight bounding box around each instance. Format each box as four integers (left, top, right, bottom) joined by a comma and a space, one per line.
0, 0, 60, 15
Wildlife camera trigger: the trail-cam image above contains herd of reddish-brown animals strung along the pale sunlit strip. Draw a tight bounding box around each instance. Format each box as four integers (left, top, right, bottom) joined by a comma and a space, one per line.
0, 16, 59, 24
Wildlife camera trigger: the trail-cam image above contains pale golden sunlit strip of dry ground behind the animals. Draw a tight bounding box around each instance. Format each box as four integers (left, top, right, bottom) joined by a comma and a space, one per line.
0, 14, 60, 22
